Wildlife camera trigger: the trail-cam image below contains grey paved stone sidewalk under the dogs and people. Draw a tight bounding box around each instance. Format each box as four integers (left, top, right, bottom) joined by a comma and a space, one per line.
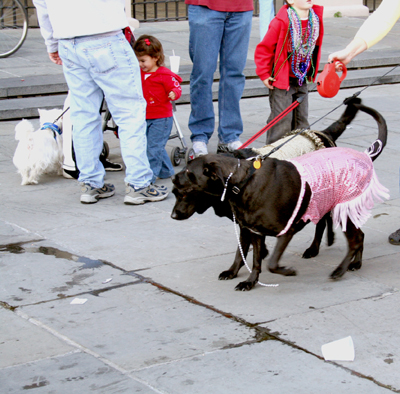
0, 13, 400, 394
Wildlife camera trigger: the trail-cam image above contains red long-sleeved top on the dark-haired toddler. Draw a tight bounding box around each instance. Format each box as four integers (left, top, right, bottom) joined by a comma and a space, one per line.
141, 67, 182, 119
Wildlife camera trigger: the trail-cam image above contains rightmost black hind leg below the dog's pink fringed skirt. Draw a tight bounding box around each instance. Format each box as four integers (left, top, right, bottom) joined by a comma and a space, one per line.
331, 219, 364, 279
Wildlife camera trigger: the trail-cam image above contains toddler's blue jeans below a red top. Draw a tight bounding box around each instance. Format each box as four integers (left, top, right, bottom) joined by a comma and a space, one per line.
146, 117, 174, 183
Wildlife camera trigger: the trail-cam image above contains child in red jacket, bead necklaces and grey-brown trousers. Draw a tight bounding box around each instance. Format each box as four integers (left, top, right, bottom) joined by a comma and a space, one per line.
254, 0, 324, 144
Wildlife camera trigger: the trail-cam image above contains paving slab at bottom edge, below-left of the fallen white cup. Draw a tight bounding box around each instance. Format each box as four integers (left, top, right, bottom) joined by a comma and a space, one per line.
132, 341, 394, 394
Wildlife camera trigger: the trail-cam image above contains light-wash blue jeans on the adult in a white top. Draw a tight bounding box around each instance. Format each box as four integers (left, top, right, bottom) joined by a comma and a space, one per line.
58, 33, 153, 188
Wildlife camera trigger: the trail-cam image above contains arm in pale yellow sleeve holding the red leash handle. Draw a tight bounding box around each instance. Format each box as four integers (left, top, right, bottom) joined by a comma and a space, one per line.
328, 0, 400, 64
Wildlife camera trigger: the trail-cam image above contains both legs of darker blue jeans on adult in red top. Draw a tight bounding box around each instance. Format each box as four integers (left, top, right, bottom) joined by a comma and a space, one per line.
188, 5, 253, 144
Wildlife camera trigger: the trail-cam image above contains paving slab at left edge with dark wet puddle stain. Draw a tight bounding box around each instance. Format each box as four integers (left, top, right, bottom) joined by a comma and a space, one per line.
0, 242, 137, 307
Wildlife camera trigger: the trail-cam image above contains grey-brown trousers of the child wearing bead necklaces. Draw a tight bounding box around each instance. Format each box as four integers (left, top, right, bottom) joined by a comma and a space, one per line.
267, 78, 310, 144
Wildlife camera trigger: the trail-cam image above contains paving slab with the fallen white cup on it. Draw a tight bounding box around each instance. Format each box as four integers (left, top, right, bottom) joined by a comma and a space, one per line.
267, 292, 400, 391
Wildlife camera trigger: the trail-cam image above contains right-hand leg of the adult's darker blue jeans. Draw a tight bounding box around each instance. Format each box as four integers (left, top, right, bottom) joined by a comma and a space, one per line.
218, 11, 253, 144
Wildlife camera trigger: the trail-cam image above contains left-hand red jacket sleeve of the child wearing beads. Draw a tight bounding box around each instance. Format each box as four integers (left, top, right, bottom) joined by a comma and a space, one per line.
254, 19, 281, 81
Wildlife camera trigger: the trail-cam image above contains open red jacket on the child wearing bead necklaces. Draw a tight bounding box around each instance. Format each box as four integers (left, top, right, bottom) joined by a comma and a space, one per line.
254, 5, 324, 90
